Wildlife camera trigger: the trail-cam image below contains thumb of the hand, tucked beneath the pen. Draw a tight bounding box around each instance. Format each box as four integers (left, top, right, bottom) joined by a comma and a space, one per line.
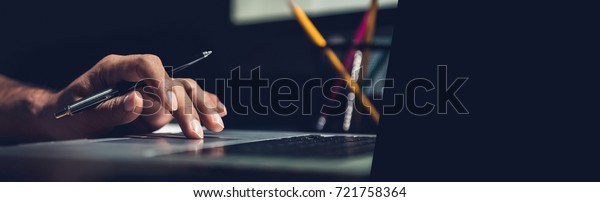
86, 91, 143, 128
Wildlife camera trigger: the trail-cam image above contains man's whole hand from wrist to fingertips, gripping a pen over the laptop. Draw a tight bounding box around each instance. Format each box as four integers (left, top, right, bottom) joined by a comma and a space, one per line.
1, 55, 227, 142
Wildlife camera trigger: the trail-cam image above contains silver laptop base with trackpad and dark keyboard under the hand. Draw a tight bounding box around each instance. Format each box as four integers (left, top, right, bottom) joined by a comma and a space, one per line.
0, 123, 375, 181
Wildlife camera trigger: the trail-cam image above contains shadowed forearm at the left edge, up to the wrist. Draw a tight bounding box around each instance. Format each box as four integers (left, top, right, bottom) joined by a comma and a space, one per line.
0, 75, 53, 140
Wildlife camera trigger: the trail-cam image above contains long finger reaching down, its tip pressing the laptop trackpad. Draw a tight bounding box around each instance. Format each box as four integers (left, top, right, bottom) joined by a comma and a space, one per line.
171, 81, 204, 139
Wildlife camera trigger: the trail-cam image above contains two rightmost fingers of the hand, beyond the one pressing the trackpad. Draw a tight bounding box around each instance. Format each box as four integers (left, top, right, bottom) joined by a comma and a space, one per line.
176, 79, 226, 132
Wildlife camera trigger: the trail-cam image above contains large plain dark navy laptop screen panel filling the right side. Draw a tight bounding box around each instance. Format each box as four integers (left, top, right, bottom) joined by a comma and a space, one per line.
372, 0, 600, 180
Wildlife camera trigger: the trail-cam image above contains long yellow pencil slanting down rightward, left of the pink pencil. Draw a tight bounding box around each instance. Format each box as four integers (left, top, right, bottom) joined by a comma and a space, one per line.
290, 0, 380, 123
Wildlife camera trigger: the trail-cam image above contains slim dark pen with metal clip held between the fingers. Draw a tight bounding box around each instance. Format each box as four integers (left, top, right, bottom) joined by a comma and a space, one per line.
54, 51, 212, 119
